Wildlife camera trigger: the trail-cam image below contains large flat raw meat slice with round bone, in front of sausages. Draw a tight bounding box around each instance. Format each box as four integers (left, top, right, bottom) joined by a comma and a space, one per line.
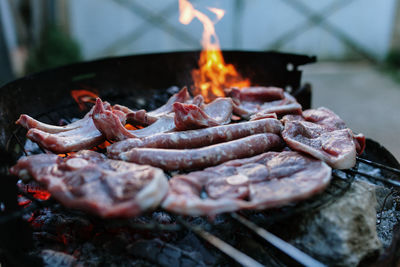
161, 151, 331, 216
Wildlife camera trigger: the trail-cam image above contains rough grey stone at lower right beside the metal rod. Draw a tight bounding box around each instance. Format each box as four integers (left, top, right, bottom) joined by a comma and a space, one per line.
290, 181, 382, 266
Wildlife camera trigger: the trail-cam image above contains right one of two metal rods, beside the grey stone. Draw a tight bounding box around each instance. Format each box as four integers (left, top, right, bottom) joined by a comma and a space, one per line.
231, 213, 326, 267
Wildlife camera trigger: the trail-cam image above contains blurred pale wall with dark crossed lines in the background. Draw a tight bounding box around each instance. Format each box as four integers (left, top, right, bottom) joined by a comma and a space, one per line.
69, 0, 396, 59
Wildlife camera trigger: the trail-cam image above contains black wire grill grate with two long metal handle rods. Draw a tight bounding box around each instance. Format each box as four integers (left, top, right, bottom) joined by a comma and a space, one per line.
0, 101, 400, 266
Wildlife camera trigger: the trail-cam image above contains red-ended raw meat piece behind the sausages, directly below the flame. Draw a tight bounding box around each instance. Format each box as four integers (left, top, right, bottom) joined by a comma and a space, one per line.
174, 97, 232, 131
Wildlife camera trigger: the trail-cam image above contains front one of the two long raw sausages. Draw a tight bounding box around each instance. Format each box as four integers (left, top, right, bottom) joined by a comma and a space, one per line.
118, 133, 284, 170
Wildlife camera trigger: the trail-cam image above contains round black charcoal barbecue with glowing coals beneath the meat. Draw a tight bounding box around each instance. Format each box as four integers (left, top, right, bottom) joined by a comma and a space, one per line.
0, 51, 400, 266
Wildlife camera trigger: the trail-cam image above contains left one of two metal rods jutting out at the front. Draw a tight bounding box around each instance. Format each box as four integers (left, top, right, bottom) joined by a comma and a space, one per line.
177, 218, 264, 267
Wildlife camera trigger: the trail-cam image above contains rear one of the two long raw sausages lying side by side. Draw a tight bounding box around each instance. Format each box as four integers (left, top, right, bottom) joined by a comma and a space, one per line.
107, 119, 283, 158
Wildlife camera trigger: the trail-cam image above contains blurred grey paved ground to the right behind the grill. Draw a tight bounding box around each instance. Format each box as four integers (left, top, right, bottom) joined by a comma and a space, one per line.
302, 62, 400, 161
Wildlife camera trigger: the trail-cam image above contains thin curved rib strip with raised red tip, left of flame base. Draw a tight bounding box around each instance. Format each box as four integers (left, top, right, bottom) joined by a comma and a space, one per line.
114, 87, 191, 126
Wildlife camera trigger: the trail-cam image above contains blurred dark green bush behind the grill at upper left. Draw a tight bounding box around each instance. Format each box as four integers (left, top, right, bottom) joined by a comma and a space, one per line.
26, 26, 82, 73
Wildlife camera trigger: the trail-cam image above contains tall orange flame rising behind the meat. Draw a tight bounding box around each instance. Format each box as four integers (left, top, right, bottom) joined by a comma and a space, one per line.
179, 0, 250, 102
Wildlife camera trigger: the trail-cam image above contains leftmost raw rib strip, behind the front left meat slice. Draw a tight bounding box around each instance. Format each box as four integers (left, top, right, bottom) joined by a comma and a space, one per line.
17, 102, 125, 154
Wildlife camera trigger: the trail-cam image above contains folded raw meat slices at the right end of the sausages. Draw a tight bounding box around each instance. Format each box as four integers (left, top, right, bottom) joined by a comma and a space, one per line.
282, 108, 365, 169
